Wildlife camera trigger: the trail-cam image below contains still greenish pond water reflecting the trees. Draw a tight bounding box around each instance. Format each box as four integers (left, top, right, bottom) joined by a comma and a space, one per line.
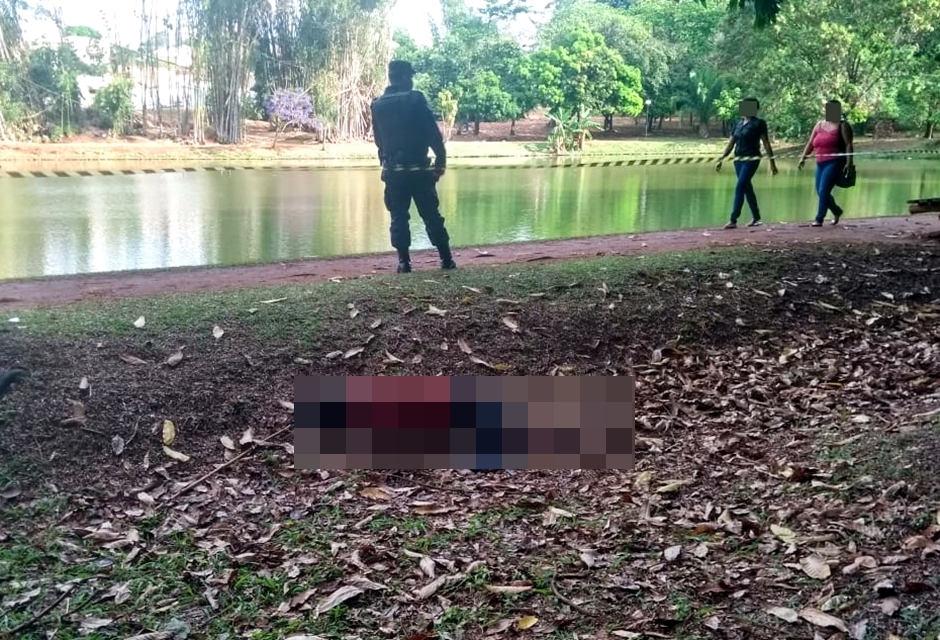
0, 159, 940, 279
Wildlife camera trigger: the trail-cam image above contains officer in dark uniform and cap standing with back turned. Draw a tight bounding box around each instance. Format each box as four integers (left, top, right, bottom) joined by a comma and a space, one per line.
372, 60, 457, 273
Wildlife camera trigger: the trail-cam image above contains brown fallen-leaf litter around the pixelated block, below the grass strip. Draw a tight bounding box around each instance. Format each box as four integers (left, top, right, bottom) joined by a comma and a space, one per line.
0, 242, 940, 640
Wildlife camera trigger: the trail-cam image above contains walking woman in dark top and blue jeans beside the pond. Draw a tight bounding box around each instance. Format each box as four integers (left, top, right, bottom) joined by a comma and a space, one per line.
715, 98, 777, 229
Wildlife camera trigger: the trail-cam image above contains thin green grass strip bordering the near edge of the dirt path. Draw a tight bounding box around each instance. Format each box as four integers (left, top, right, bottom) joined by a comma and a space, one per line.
3, 247, 800, 343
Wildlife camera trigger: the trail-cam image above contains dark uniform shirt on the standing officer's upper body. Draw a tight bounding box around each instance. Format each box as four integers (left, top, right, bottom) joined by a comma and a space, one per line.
372, 87, 447, 168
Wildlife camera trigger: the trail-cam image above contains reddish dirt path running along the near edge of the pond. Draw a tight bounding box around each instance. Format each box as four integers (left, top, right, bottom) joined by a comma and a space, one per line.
0, 215, 940, 309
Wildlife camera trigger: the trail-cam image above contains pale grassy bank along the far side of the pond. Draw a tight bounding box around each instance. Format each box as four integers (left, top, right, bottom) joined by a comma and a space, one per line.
0, 138, 937, 171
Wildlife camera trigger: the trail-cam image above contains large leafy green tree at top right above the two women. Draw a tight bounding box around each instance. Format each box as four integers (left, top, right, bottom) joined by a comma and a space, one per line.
715, 0, 940, 137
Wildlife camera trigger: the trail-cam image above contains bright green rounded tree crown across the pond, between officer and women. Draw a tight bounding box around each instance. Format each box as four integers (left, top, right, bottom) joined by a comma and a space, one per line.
532, 27, 644, 127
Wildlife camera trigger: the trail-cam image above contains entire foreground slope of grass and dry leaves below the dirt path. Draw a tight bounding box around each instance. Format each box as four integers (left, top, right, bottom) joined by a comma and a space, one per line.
0, 245, 940, 640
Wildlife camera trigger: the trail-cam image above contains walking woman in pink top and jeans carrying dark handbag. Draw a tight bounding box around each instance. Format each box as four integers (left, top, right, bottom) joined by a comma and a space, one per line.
797, 100, 855, 227
